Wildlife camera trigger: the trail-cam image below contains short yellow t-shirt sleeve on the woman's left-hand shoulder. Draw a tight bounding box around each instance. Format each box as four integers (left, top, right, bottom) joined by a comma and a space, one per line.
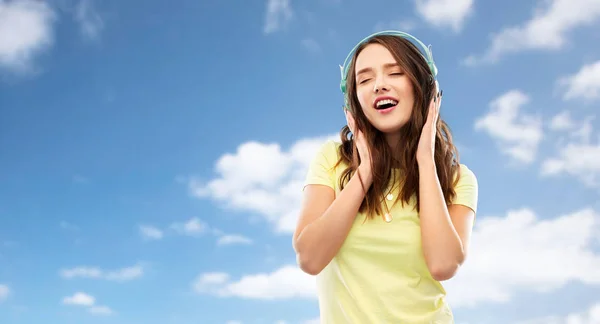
302, 141, 337, 190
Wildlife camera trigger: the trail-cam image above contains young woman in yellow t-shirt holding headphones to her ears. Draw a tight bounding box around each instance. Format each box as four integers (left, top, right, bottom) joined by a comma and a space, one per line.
293, 31, 478, 324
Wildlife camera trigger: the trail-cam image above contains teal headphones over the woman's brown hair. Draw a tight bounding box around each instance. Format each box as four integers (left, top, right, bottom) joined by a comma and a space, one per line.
340, 30, 439, 109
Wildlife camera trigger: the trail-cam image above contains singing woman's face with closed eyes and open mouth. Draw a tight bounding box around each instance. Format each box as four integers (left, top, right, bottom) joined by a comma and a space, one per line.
355, 44, 414, 134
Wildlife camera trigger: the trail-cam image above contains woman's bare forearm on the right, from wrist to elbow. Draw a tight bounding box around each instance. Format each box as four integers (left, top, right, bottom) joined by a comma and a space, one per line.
419, 161, 465, 277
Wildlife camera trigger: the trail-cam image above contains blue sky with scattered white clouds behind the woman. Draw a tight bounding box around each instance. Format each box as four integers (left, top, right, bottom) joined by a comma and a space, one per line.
0, 0, 600, 324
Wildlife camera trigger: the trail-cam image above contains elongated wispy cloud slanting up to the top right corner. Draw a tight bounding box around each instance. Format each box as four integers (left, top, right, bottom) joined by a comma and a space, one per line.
465, 0, 600, 65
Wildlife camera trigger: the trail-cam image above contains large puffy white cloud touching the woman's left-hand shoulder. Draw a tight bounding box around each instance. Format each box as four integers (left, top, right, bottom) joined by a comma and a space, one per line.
189, 135, 338, 233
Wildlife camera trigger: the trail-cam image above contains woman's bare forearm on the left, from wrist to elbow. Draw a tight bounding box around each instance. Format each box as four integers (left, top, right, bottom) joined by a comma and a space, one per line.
296, 166, 373, 274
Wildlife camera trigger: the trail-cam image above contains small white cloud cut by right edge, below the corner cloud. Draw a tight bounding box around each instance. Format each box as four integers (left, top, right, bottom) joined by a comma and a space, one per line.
558, 60, 600, 102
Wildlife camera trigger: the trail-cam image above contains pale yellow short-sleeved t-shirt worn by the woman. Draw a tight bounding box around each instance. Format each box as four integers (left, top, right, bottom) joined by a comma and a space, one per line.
305, 141, 478, 324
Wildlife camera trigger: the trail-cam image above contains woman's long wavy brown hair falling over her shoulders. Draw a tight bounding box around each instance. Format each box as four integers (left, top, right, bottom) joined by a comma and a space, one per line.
337, 35, 460, 218
